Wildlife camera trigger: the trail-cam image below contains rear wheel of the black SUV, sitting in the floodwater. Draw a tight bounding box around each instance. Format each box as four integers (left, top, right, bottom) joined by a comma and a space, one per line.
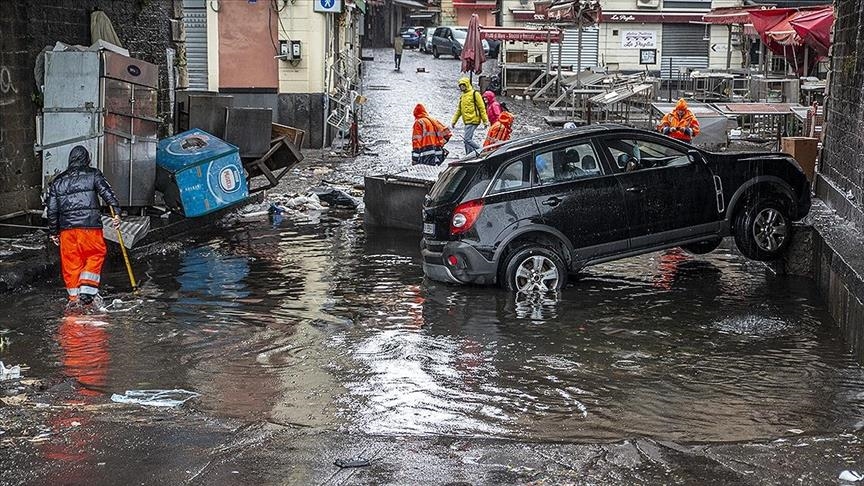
501, 244, 567, 292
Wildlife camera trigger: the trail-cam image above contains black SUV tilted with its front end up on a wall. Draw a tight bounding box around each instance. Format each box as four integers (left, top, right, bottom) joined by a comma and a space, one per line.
421, 125, 810, 291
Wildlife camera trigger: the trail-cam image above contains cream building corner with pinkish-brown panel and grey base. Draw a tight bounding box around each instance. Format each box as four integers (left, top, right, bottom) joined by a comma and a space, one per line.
183, 0, 367, 147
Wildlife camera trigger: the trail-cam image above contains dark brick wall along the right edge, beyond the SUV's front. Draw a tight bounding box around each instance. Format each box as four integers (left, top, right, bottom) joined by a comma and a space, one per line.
817, 0, 864, 226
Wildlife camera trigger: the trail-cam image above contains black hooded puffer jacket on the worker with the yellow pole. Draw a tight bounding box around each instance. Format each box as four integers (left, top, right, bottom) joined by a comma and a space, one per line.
48, 145, 120, 235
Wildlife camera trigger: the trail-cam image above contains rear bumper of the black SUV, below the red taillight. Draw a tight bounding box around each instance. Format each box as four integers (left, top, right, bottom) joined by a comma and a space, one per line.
421, 239, 498, 285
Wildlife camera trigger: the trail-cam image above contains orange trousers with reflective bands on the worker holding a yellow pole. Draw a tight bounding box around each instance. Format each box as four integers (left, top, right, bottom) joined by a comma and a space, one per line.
60, 228, 107, 300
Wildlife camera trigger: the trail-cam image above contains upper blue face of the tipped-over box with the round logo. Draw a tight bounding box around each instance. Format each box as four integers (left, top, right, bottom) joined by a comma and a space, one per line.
156, 128, 239, 172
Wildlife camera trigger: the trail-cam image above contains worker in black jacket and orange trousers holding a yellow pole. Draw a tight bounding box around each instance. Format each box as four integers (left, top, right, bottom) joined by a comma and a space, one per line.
48, 145, 120, 304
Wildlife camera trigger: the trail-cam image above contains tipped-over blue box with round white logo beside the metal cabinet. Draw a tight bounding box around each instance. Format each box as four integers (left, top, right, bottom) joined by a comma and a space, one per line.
156, 128, 249, 217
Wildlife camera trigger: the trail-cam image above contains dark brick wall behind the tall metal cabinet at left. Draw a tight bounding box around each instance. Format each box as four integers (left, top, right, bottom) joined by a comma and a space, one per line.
0, 0, 175, 215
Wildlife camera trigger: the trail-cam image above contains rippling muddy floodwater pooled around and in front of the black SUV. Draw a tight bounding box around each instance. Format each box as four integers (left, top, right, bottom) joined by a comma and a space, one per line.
0, 215, 864, 441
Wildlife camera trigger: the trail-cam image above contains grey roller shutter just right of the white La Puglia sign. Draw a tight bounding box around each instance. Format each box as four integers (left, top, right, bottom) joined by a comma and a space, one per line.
660, 24, 711, 79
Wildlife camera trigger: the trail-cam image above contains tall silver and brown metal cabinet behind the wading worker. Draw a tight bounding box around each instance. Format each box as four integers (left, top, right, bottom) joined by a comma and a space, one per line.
38, 50, 159, 207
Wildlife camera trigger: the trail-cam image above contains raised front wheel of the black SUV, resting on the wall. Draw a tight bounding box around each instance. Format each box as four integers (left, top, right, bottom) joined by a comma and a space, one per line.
735, 199, 791, 261
